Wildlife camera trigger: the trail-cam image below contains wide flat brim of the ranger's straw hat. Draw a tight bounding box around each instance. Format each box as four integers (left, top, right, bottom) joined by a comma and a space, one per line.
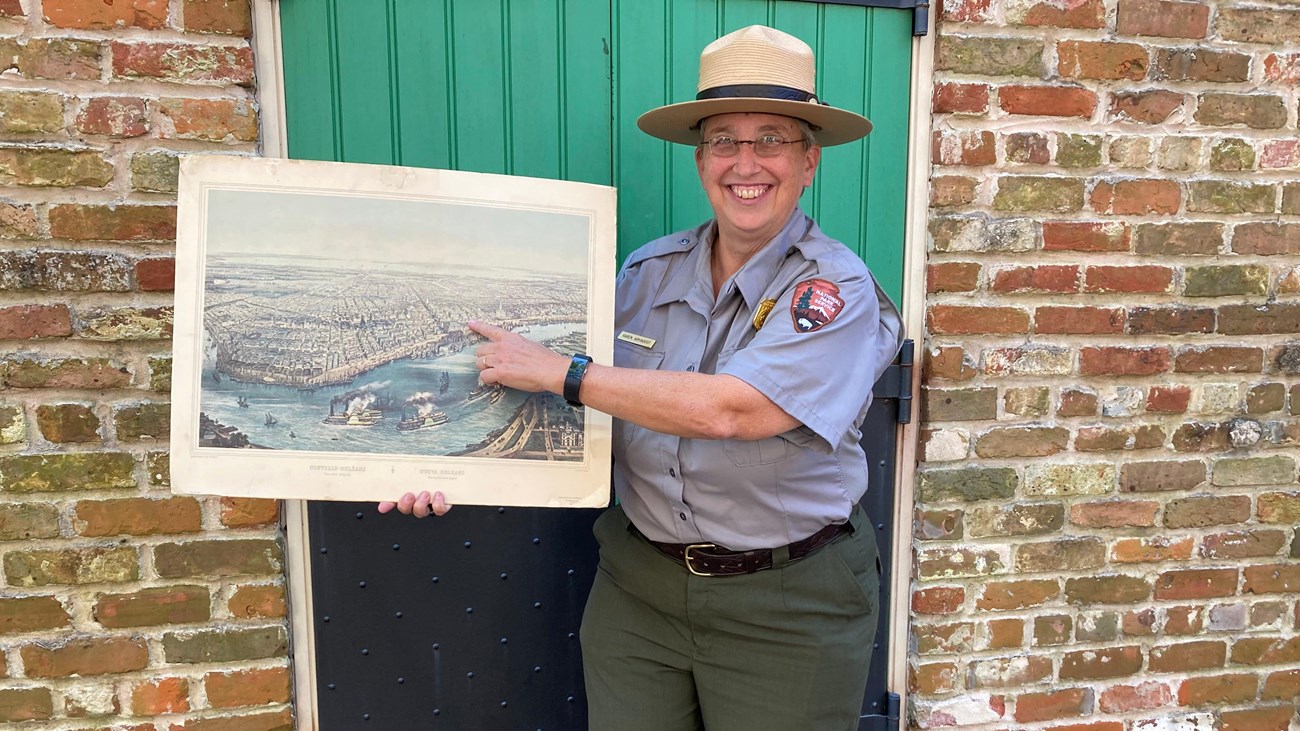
637, 96, 871, 147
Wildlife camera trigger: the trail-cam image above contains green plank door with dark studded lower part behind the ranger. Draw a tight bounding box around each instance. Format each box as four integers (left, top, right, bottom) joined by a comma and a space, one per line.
280, 0, 913, 731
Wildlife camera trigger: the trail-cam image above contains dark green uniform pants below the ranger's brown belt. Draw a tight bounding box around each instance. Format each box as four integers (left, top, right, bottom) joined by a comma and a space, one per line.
581, 506, 880, 731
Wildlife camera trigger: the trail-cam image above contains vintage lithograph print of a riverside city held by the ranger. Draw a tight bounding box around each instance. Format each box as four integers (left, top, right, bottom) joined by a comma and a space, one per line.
172, 156, 615, 506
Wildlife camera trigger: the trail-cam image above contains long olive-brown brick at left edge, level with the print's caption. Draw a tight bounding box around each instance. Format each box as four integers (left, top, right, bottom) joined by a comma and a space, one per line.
0, 451, 135, 493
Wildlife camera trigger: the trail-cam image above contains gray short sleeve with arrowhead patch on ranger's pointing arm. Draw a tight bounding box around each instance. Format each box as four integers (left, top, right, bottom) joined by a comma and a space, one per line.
718, 267, 902, 449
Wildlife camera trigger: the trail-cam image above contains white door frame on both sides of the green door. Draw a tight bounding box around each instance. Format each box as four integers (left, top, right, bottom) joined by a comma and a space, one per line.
252, 0, 935, 731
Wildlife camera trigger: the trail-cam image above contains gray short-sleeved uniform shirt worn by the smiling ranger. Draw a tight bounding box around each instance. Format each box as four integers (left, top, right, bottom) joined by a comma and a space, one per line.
614, 209, 902, 550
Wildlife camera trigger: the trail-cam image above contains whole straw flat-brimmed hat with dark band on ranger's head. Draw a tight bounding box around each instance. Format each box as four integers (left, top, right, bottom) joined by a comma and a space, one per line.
637, 26, 871, 146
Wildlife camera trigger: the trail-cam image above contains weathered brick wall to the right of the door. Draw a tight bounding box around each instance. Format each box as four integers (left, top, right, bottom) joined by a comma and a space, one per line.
909, 0, 1300, 731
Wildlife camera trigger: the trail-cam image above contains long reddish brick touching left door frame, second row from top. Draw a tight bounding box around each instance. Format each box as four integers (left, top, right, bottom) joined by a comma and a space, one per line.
113, 43, 254, 86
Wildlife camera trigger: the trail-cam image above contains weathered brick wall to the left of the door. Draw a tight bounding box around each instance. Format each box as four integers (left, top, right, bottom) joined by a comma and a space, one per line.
0, 0, 291, 731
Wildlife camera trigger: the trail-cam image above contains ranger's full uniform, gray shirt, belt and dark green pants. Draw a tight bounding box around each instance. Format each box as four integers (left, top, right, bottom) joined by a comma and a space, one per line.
582, 208, 902, 731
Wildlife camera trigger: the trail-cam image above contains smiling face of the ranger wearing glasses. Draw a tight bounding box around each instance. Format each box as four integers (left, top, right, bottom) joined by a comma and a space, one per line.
696, 113, 822, 251
